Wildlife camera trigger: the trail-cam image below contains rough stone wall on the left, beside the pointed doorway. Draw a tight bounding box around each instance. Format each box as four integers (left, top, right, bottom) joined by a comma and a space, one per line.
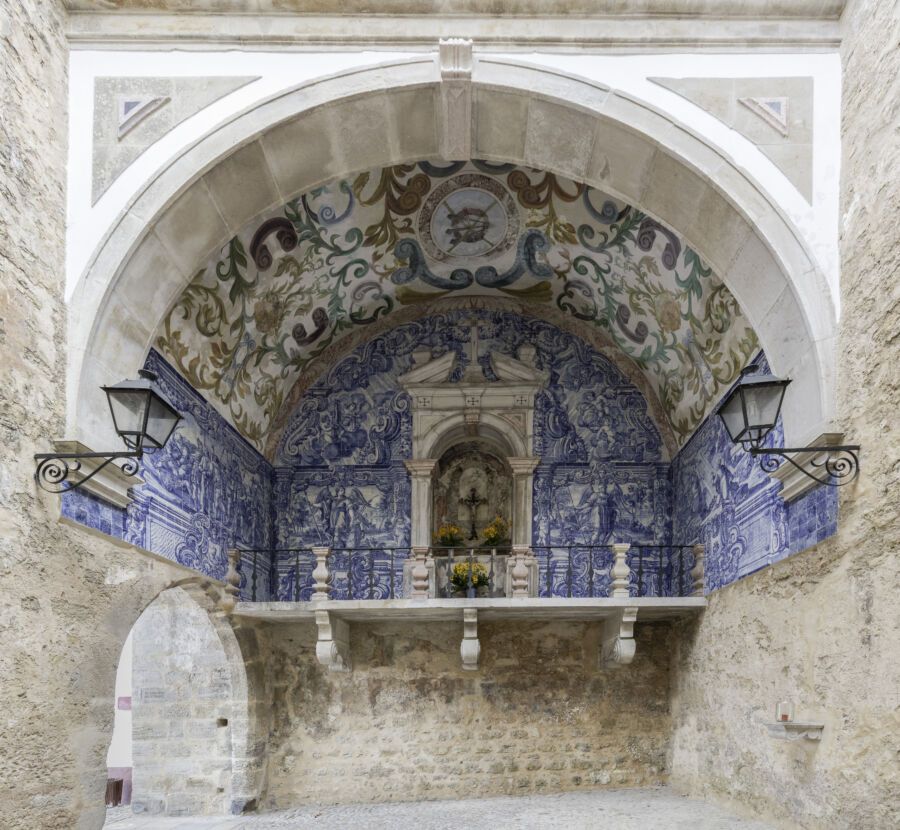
0, 0, 229, 830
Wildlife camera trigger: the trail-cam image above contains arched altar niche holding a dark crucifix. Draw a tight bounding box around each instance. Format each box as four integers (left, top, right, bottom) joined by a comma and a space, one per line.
432, 439, 512, 547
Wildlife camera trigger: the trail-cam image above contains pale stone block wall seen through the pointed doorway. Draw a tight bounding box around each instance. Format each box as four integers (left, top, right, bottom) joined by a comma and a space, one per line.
131, 588, 233, 816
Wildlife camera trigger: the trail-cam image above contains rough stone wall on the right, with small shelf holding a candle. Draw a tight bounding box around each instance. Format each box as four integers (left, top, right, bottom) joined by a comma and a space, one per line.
671, 0, 900, 830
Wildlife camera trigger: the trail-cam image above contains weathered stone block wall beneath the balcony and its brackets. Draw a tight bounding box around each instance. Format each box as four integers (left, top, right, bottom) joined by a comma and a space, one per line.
265, 622, 671, 808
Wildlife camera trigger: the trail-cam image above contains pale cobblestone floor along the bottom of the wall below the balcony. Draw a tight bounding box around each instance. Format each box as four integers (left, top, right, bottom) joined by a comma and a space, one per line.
104, 788, 772, 830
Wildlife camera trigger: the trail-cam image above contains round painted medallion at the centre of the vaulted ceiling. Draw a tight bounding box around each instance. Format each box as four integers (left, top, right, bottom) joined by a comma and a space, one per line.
418, 173, 519, 260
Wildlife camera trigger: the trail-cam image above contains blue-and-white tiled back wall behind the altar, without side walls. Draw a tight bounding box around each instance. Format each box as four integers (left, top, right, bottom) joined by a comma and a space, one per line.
274, 311, 671, 597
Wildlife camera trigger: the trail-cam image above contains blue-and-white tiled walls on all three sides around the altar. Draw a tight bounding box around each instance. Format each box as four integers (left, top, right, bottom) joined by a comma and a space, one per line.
63, 322, 837, 599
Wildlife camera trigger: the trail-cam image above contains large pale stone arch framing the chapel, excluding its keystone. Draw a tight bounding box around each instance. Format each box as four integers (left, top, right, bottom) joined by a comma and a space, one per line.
67, 56, 836, 458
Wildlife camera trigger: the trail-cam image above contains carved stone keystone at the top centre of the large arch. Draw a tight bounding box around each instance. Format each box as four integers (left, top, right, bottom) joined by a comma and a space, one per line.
439, 38, 472, 161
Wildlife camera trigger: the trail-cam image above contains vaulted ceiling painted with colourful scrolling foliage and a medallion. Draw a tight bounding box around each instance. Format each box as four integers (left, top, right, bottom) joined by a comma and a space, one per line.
155, 161, 757, 450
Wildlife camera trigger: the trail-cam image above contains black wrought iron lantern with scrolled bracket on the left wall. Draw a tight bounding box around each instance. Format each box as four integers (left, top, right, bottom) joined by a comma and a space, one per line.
34, 369, 181, 493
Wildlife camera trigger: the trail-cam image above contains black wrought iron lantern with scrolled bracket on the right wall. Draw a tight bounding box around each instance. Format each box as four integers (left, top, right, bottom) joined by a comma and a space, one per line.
717, 365, 859, 487
